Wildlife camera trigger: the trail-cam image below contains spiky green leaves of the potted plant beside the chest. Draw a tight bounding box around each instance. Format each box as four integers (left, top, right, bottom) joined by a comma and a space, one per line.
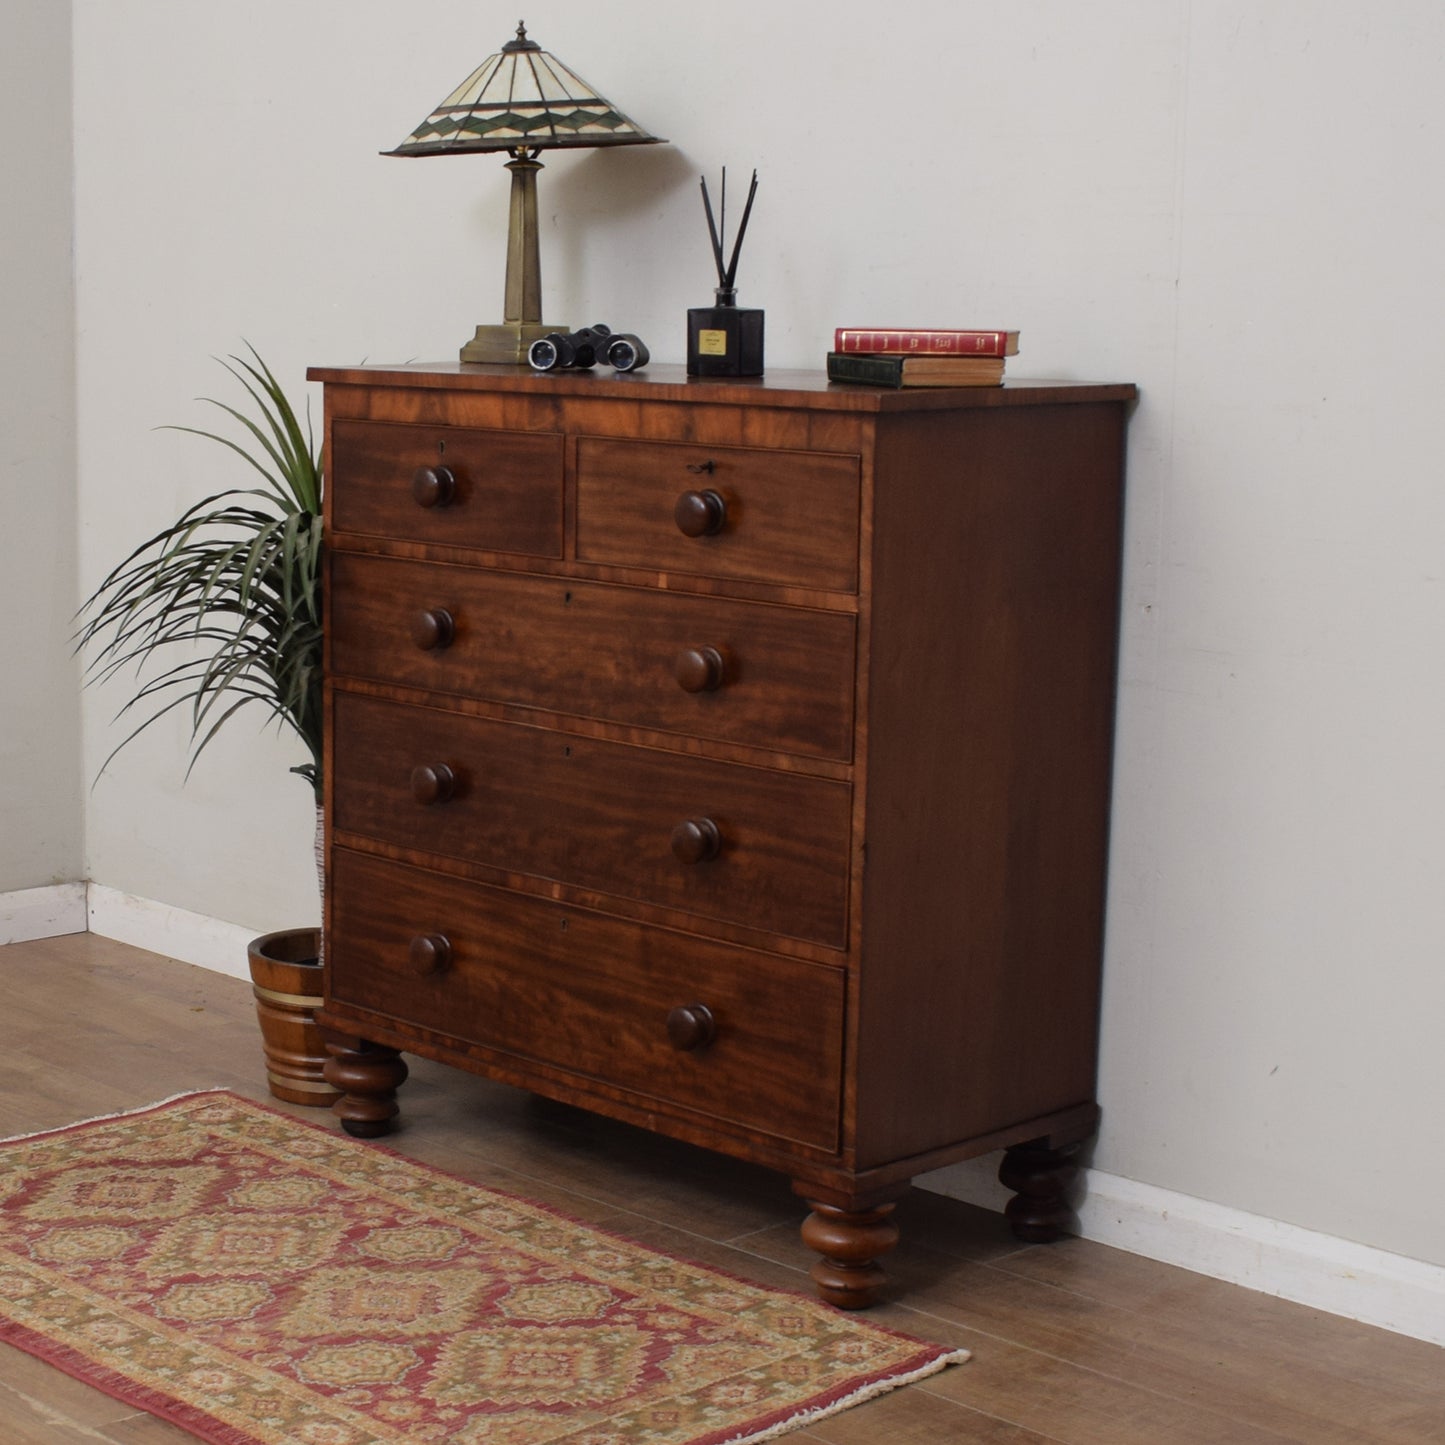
75, 342, 321, 802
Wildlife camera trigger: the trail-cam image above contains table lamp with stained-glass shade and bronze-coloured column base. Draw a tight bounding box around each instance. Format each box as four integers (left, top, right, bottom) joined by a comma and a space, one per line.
386, 25, 660, 364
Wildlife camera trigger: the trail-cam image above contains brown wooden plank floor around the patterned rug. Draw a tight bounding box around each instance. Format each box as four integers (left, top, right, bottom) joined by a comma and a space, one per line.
0, 935, 1445, 1445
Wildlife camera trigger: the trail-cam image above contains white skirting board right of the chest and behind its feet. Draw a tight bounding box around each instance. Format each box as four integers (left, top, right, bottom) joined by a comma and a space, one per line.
916, 1157, 1445, 1344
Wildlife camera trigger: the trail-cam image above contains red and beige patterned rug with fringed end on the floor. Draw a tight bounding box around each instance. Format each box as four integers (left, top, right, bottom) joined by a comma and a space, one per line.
0, 1092, 968, 1445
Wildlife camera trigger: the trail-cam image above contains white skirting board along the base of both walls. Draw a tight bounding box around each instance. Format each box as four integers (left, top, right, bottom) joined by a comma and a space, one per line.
0, 883, 1445, 1344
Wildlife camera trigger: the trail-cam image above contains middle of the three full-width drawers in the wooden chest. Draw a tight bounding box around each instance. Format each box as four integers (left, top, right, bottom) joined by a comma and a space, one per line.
332, 689, 851, 948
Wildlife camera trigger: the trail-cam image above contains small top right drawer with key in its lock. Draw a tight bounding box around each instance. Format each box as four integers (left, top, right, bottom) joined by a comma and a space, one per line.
577, 436, 860, 592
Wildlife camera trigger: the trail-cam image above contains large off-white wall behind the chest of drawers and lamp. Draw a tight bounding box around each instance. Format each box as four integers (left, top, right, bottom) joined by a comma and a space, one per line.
62, 0, 1445, 1264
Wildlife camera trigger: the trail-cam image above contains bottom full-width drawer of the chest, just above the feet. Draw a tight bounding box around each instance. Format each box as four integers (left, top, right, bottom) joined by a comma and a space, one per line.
327, 848, 844, 1150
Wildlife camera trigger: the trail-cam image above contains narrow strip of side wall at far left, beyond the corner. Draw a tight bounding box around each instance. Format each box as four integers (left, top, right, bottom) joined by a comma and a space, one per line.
0, 0, 84, 893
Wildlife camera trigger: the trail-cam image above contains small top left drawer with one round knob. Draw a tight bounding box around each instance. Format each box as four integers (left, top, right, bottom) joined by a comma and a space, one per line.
327, 420, 562, 558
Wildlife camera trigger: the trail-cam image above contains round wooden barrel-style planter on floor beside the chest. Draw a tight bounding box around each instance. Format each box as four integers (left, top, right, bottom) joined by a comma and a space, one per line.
247, 928, 341, 1108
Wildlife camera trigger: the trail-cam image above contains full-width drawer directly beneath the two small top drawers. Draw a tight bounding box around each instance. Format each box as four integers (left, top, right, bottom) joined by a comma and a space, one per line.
329, 552, 855, 762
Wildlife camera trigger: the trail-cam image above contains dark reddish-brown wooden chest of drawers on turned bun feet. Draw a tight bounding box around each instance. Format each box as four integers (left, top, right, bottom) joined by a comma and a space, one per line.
312, 366, 1134, 1306
